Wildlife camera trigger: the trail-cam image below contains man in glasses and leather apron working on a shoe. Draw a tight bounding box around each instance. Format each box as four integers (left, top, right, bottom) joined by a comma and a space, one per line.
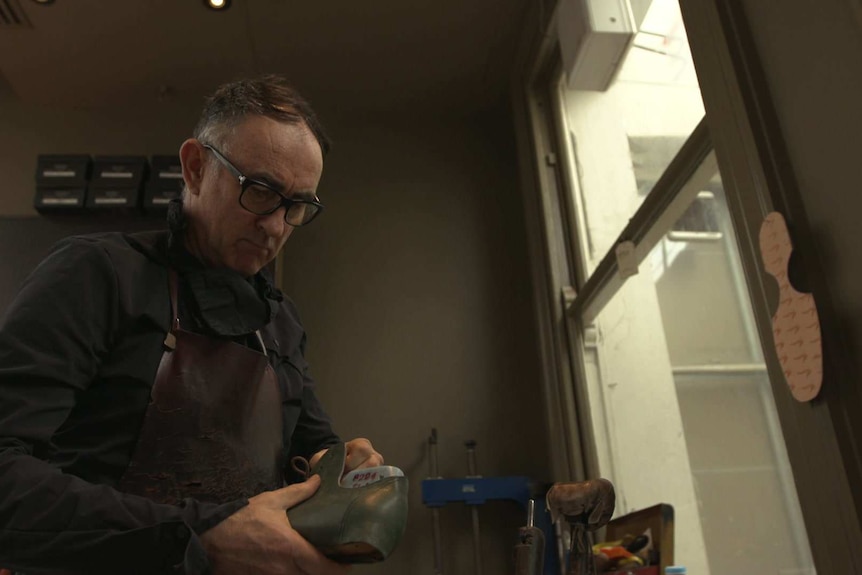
0, 76, 383, 575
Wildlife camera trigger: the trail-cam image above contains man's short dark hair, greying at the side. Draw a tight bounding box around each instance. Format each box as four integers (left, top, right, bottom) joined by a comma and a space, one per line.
194, 74, 331, 156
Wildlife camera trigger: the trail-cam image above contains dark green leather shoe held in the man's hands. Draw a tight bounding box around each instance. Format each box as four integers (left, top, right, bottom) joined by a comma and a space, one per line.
287, 443, 408, 563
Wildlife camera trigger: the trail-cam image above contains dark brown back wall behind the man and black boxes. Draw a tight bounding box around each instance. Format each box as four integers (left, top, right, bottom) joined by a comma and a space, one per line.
0, 88, 548, 575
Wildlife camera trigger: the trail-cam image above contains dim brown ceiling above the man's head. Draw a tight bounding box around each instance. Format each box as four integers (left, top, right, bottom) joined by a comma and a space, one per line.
0, 0, 530, 114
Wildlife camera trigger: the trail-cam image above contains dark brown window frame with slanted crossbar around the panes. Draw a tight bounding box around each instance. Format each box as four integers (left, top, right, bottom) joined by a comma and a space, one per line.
513, 0, 862, 575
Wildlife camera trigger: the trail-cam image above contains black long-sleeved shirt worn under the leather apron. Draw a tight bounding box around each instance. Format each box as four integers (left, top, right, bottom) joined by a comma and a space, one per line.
0, 232, 338, 573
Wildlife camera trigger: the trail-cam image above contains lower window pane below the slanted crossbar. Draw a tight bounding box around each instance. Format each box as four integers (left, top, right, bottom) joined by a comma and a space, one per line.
585, 169, 814, 575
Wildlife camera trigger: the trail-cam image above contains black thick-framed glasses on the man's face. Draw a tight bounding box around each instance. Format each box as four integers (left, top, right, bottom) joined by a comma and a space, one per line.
203, 144, 323, 226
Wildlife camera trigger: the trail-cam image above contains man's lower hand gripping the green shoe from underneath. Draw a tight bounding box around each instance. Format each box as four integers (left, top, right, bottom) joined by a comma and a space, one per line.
201, 475, 348, 575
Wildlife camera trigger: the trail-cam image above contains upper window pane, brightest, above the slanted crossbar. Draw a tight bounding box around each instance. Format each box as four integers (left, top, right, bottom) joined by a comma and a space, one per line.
560, 0, 704, 273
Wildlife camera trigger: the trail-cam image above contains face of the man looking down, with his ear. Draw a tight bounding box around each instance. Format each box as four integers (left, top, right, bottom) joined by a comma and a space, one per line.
180, 116, 323, 276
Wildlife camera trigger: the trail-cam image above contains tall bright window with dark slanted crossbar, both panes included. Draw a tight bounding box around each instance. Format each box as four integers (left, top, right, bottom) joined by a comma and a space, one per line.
532, 0, 832, 575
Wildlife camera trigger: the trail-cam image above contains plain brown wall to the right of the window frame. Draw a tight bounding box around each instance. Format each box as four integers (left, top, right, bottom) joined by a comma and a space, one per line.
743, 0, 862, 338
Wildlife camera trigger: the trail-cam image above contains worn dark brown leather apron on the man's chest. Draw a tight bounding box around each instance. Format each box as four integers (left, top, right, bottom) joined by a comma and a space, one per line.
117, 270, 283, 504
